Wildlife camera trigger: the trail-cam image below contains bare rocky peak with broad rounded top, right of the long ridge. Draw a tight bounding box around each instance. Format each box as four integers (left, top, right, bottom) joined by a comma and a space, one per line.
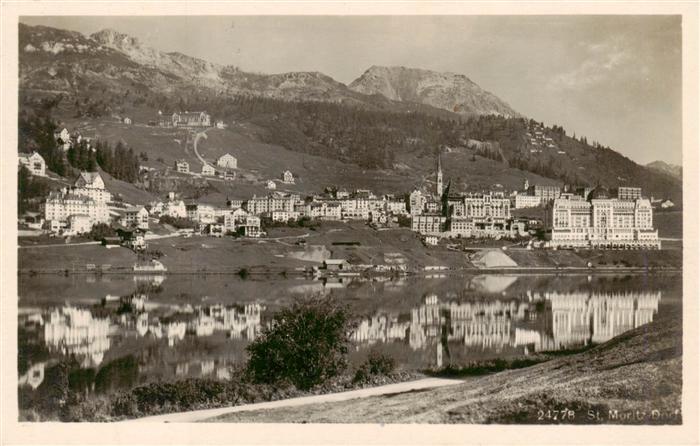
350, 66, 520, 117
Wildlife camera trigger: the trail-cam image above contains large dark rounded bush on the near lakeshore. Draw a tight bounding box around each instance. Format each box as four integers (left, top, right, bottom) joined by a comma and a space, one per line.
247, 297, 352, 390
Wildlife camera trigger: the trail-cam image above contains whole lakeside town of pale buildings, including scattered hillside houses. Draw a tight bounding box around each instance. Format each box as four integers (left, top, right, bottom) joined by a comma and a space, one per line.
19, 112, 674, 272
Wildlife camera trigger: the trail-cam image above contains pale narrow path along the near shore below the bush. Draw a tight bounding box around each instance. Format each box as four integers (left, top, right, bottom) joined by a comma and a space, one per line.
124, 378, 464, 423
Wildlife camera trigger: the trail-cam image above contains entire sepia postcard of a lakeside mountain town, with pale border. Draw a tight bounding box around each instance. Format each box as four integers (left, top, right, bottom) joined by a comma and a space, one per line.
2, 1, 698, 442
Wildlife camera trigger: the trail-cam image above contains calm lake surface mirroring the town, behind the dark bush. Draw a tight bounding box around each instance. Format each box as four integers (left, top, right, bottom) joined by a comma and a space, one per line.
19, 275, 682, 391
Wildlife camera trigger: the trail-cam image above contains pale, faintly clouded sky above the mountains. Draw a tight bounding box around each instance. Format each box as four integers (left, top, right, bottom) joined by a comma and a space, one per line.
21, 16, 682, 164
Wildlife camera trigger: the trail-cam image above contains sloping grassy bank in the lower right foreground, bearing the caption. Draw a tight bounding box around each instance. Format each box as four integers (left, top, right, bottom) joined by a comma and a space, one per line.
208, 309, 683, 424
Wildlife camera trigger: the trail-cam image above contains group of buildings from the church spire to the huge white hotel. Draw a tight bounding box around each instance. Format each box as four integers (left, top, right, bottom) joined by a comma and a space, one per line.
409, 158, 661, 249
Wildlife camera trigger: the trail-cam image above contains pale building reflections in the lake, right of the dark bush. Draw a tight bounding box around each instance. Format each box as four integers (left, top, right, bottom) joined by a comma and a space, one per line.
352, 291, 661, 366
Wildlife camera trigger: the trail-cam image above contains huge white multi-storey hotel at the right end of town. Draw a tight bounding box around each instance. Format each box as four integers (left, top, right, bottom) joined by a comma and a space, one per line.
545, 186, 661, 249
